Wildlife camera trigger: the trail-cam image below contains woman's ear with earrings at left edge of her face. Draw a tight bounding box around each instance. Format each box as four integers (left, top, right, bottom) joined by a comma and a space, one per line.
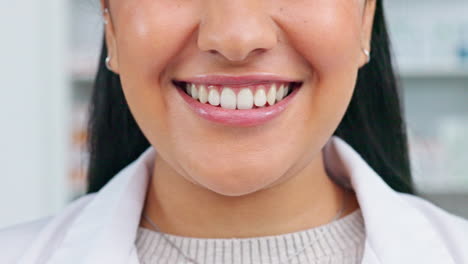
100, 0, 119, 74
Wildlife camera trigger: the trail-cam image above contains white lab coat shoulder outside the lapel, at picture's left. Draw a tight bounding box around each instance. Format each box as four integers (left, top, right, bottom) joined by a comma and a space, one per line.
0, 194, 94, 264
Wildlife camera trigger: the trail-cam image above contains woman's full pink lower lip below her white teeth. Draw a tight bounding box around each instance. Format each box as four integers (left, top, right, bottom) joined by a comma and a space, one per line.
176, 83, 300, 127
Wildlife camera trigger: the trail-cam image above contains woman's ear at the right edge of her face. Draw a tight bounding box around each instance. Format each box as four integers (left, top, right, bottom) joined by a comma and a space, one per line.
360, 0, 380, 67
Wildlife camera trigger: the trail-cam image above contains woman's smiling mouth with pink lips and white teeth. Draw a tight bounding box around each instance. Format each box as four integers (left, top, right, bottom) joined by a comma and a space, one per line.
172, 76, 303, 126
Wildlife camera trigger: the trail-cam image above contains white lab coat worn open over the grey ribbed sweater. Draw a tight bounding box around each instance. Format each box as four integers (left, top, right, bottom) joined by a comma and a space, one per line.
0, 136, 468, 264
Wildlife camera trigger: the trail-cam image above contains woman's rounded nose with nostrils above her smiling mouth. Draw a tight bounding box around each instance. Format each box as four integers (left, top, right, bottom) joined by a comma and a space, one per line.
197, 5, 277, 62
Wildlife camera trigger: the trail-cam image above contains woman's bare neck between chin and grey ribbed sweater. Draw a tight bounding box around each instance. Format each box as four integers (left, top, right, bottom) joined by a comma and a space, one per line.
140, 152, 358, 238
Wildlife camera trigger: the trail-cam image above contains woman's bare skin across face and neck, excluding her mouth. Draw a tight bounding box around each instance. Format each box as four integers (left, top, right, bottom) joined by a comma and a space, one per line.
101, 0, 377, 238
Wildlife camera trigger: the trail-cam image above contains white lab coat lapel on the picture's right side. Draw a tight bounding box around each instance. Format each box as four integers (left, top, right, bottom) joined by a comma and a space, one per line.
324, 137, 455, 264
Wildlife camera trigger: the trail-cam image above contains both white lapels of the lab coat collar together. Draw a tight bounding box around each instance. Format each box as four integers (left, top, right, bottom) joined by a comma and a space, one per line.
37, 136, 454, 264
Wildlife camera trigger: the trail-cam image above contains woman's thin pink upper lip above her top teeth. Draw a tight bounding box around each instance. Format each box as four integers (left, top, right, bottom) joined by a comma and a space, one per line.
175, 74, 301, 86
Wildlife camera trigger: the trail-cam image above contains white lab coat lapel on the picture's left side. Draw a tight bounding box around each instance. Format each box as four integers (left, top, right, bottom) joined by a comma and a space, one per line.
42, 147, 156, 264
